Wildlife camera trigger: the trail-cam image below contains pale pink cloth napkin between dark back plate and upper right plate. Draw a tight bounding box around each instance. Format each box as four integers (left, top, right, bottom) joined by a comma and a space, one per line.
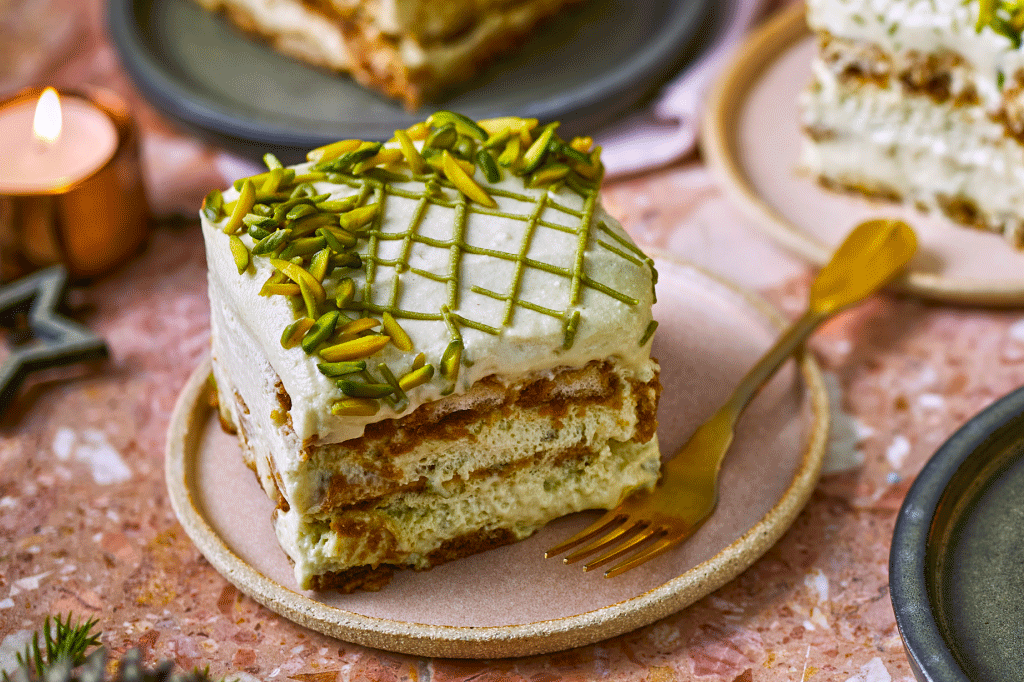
596, 0, 773, 177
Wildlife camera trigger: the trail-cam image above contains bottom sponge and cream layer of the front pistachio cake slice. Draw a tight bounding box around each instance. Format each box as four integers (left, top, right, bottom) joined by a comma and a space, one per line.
274, 436, 660, 589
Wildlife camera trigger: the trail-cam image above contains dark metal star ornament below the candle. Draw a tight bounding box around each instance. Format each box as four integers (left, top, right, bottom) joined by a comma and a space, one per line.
0, 265, 106, 414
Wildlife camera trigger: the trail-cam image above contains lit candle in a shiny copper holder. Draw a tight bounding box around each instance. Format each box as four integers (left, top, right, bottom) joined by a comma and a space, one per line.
0, 88, 146, 280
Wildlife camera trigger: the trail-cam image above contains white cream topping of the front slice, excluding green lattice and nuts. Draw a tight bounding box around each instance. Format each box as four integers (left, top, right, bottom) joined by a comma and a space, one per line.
203, 159, 655, 448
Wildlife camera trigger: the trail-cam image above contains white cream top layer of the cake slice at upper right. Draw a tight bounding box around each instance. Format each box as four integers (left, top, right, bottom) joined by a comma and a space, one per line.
807, 0, 1024, 111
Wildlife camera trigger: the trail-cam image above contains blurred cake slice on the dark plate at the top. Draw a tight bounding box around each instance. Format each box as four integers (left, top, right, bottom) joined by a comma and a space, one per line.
192, 0, 581, 110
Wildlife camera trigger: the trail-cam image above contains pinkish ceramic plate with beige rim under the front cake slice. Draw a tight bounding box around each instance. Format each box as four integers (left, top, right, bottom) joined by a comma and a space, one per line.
167, 251, 828, 657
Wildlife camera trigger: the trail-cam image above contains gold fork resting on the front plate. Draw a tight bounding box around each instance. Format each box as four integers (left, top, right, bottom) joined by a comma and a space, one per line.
544, 219, 918, 578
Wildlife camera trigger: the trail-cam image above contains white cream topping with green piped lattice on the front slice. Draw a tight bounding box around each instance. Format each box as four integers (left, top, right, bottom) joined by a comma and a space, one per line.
203, 154, 653, 442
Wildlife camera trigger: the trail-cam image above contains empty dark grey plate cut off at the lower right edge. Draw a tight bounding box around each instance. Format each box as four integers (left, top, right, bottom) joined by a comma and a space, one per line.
889, 388, 1024, 682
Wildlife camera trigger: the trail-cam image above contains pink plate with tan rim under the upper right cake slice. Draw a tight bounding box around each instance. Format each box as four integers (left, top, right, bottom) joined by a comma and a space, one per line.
701, 4, 1024, 304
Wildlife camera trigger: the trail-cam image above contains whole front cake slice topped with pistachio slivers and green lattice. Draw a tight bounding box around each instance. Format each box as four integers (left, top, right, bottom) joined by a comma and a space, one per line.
202, 112, 659, 590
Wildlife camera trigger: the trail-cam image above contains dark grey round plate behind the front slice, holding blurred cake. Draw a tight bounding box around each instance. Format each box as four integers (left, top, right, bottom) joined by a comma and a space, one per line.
101, 0, 723, 160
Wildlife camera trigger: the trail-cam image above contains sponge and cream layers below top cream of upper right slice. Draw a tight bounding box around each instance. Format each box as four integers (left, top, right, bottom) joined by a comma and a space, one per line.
801, 62, 1024, 245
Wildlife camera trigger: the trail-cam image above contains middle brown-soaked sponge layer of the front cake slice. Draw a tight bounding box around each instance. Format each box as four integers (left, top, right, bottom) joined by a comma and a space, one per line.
218, 337, 660, 515
